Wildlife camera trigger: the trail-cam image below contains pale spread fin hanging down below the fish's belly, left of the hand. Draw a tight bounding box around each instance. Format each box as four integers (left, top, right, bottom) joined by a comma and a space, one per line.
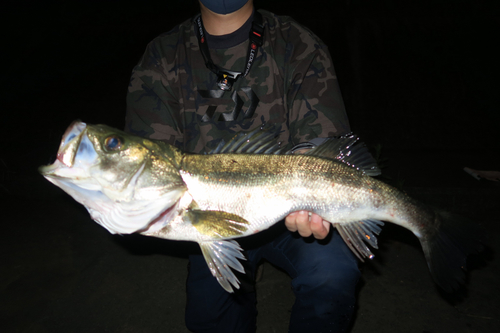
200, 241, 245, 293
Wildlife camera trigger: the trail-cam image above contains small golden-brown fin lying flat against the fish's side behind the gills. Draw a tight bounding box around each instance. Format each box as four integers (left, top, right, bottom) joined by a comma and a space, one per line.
186, 209, 249, 239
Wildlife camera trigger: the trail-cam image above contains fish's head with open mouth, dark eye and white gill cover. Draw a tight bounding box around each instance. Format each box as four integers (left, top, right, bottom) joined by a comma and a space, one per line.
39, 121, 186, 234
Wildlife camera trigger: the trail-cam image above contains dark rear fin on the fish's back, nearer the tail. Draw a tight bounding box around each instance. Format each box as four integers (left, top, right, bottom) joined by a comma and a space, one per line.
304, 134, 381, 176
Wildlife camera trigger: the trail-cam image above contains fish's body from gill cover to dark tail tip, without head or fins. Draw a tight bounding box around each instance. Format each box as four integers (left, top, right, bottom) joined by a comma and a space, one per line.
156, 154, 485, 291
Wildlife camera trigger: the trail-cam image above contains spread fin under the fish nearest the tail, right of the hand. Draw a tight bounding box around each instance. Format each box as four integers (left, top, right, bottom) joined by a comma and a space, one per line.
334, 220, 384, 261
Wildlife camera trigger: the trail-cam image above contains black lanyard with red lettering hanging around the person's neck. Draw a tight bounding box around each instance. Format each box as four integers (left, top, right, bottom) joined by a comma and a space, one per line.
194, 11, 264, 91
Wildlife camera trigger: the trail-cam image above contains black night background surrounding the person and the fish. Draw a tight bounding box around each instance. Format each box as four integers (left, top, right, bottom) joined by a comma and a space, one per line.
0, 0, 500, 333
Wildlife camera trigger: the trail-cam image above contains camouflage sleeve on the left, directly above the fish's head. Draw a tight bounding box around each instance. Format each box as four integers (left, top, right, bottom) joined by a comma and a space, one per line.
125, 41, 182, 146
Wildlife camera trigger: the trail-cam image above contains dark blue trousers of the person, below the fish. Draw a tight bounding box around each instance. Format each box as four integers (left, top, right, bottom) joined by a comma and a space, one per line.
186, 227, 361, 333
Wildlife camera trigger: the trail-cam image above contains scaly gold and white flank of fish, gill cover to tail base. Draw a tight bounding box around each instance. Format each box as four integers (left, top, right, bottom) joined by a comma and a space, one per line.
181, 154, 422, 236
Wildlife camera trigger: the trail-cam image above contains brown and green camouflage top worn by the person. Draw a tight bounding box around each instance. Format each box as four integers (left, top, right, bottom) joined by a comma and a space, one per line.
125, 10, 349, 153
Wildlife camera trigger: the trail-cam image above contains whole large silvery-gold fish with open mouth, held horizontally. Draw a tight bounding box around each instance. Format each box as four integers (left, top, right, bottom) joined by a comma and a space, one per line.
39, 121, 486, 292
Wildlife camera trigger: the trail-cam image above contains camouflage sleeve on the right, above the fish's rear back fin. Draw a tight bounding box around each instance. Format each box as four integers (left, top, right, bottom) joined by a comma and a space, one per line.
287, 24, 350, 143
